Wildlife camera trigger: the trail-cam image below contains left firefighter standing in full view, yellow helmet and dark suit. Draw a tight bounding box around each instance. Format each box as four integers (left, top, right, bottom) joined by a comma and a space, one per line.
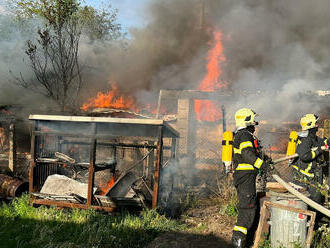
232, 108, 271, 248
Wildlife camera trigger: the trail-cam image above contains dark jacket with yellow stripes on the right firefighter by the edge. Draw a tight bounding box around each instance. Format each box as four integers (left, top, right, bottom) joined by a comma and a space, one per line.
293, 131, 330, 178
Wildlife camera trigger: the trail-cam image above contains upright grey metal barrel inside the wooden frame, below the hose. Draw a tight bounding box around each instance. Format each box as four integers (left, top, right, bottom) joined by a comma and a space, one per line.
270, 191, 307, 248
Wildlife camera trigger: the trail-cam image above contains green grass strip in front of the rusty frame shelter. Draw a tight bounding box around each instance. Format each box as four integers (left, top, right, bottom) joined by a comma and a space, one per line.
0, 195, 186, 248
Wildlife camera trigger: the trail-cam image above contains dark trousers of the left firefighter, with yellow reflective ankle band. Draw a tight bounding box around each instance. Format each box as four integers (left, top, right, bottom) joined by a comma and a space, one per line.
233, 171, 257, 246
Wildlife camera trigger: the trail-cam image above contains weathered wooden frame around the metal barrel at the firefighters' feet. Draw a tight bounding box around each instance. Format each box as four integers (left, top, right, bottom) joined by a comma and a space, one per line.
253, 201, 316, 248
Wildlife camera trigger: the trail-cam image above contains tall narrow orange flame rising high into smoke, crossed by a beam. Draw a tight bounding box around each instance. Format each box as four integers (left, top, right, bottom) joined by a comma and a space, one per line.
195, 30, 226, 121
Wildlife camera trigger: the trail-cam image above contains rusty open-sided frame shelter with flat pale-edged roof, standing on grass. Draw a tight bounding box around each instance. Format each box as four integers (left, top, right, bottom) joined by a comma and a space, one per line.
29, 115, 179, 212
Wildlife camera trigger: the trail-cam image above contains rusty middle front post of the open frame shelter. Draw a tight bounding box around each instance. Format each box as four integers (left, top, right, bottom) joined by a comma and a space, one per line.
87, 123, 96, 207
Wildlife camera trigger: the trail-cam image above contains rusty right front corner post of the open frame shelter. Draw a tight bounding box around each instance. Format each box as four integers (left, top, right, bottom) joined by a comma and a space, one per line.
152, 126, 163, 208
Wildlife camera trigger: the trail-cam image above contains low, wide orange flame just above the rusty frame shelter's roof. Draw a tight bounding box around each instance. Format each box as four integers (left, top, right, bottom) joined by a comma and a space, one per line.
81, 83, 138, 112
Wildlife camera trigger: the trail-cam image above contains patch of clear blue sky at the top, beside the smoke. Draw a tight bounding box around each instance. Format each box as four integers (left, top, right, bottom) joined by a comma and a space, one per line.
85, 0, 151, 31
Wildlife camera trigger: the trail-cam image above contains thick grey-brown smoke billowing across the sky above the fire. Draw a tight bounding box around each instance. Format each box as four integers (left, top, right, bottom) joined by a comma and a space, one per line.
0, 0, 330, 120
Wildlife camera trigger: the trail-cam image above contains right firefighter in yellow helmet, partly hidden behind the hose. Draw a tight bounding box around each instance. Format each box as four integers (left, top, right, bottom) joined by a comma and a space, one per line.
292, 114, 330, 203
